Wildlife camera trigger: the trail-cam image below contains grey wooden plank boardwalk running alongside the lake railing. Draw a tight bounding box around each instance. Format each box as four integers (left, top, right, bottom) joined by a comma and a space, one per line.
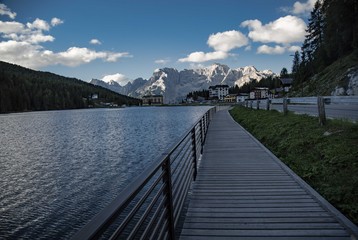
180, 111, 358, 240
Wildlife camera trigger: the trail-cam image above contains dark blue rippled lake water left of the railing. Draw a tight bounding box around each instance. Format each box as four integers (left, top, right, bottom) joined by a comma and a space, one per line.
0, 107, 209, 239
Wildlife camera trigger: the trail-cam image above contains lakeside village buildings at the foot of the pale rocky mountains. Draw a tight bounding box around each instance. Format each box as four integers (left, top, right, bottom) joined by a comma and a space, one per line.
142, 78, 293, 105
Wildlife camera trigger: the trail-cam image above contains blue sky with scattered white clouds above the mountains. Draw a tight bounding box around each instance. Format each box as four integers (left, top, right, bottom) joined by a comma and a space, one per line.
0, 0, 314, 84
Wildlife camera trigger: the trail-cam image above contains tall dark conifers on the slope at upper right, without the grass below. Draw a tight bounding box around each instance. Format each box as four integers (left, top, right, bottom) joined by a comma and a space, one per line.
292, 0, 358, 87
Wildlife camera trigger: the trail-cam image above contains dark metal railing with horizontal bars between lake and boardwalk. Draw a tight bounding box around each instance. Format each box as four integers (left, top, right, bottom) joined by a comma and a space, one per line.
72, 108, 216, 240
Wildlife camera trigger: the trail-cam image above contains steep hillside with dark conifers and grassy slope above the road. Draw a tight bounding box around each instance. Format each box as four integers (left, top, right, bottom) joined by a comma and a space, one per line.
292, 0, 358, 95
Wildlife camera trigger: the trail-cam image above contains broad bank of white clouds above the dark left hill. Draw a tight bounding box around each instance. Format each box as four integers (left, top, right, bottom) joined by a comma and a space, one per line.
0, 4, 132, 69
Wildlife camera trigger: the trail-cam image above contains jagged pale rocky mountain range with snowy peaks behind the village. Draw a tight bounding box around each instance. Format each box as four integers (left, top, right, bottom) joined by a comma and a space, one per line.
91, 63, 275, 103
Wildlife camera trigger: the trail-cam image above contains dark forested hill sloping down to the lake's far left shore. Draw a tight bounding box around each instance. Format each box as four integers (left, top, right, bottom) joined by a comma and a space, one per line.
0, 61, 140, 113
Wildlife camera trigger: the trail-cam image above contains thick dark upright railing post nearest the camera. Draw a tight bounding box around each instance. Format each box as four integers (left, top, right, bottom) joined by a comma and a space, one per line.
162, 156, 175, 240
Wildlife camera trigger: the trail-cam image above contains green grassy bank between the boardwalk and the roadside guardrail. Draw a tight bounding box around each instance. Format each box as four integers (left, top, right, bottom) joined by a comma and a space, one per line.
230, 107, 358, 224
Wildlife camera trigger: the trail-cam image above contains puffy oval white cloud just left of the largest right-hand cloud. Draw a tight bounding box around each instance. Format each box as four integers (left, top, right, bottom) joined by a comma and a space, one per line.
207, 30, 249, 52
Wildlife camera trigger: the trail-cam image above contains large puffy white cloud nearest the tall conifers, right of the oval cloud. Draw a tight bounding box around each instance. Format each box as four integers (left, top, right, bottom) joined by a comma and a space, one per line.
241, 15, 306, 44
